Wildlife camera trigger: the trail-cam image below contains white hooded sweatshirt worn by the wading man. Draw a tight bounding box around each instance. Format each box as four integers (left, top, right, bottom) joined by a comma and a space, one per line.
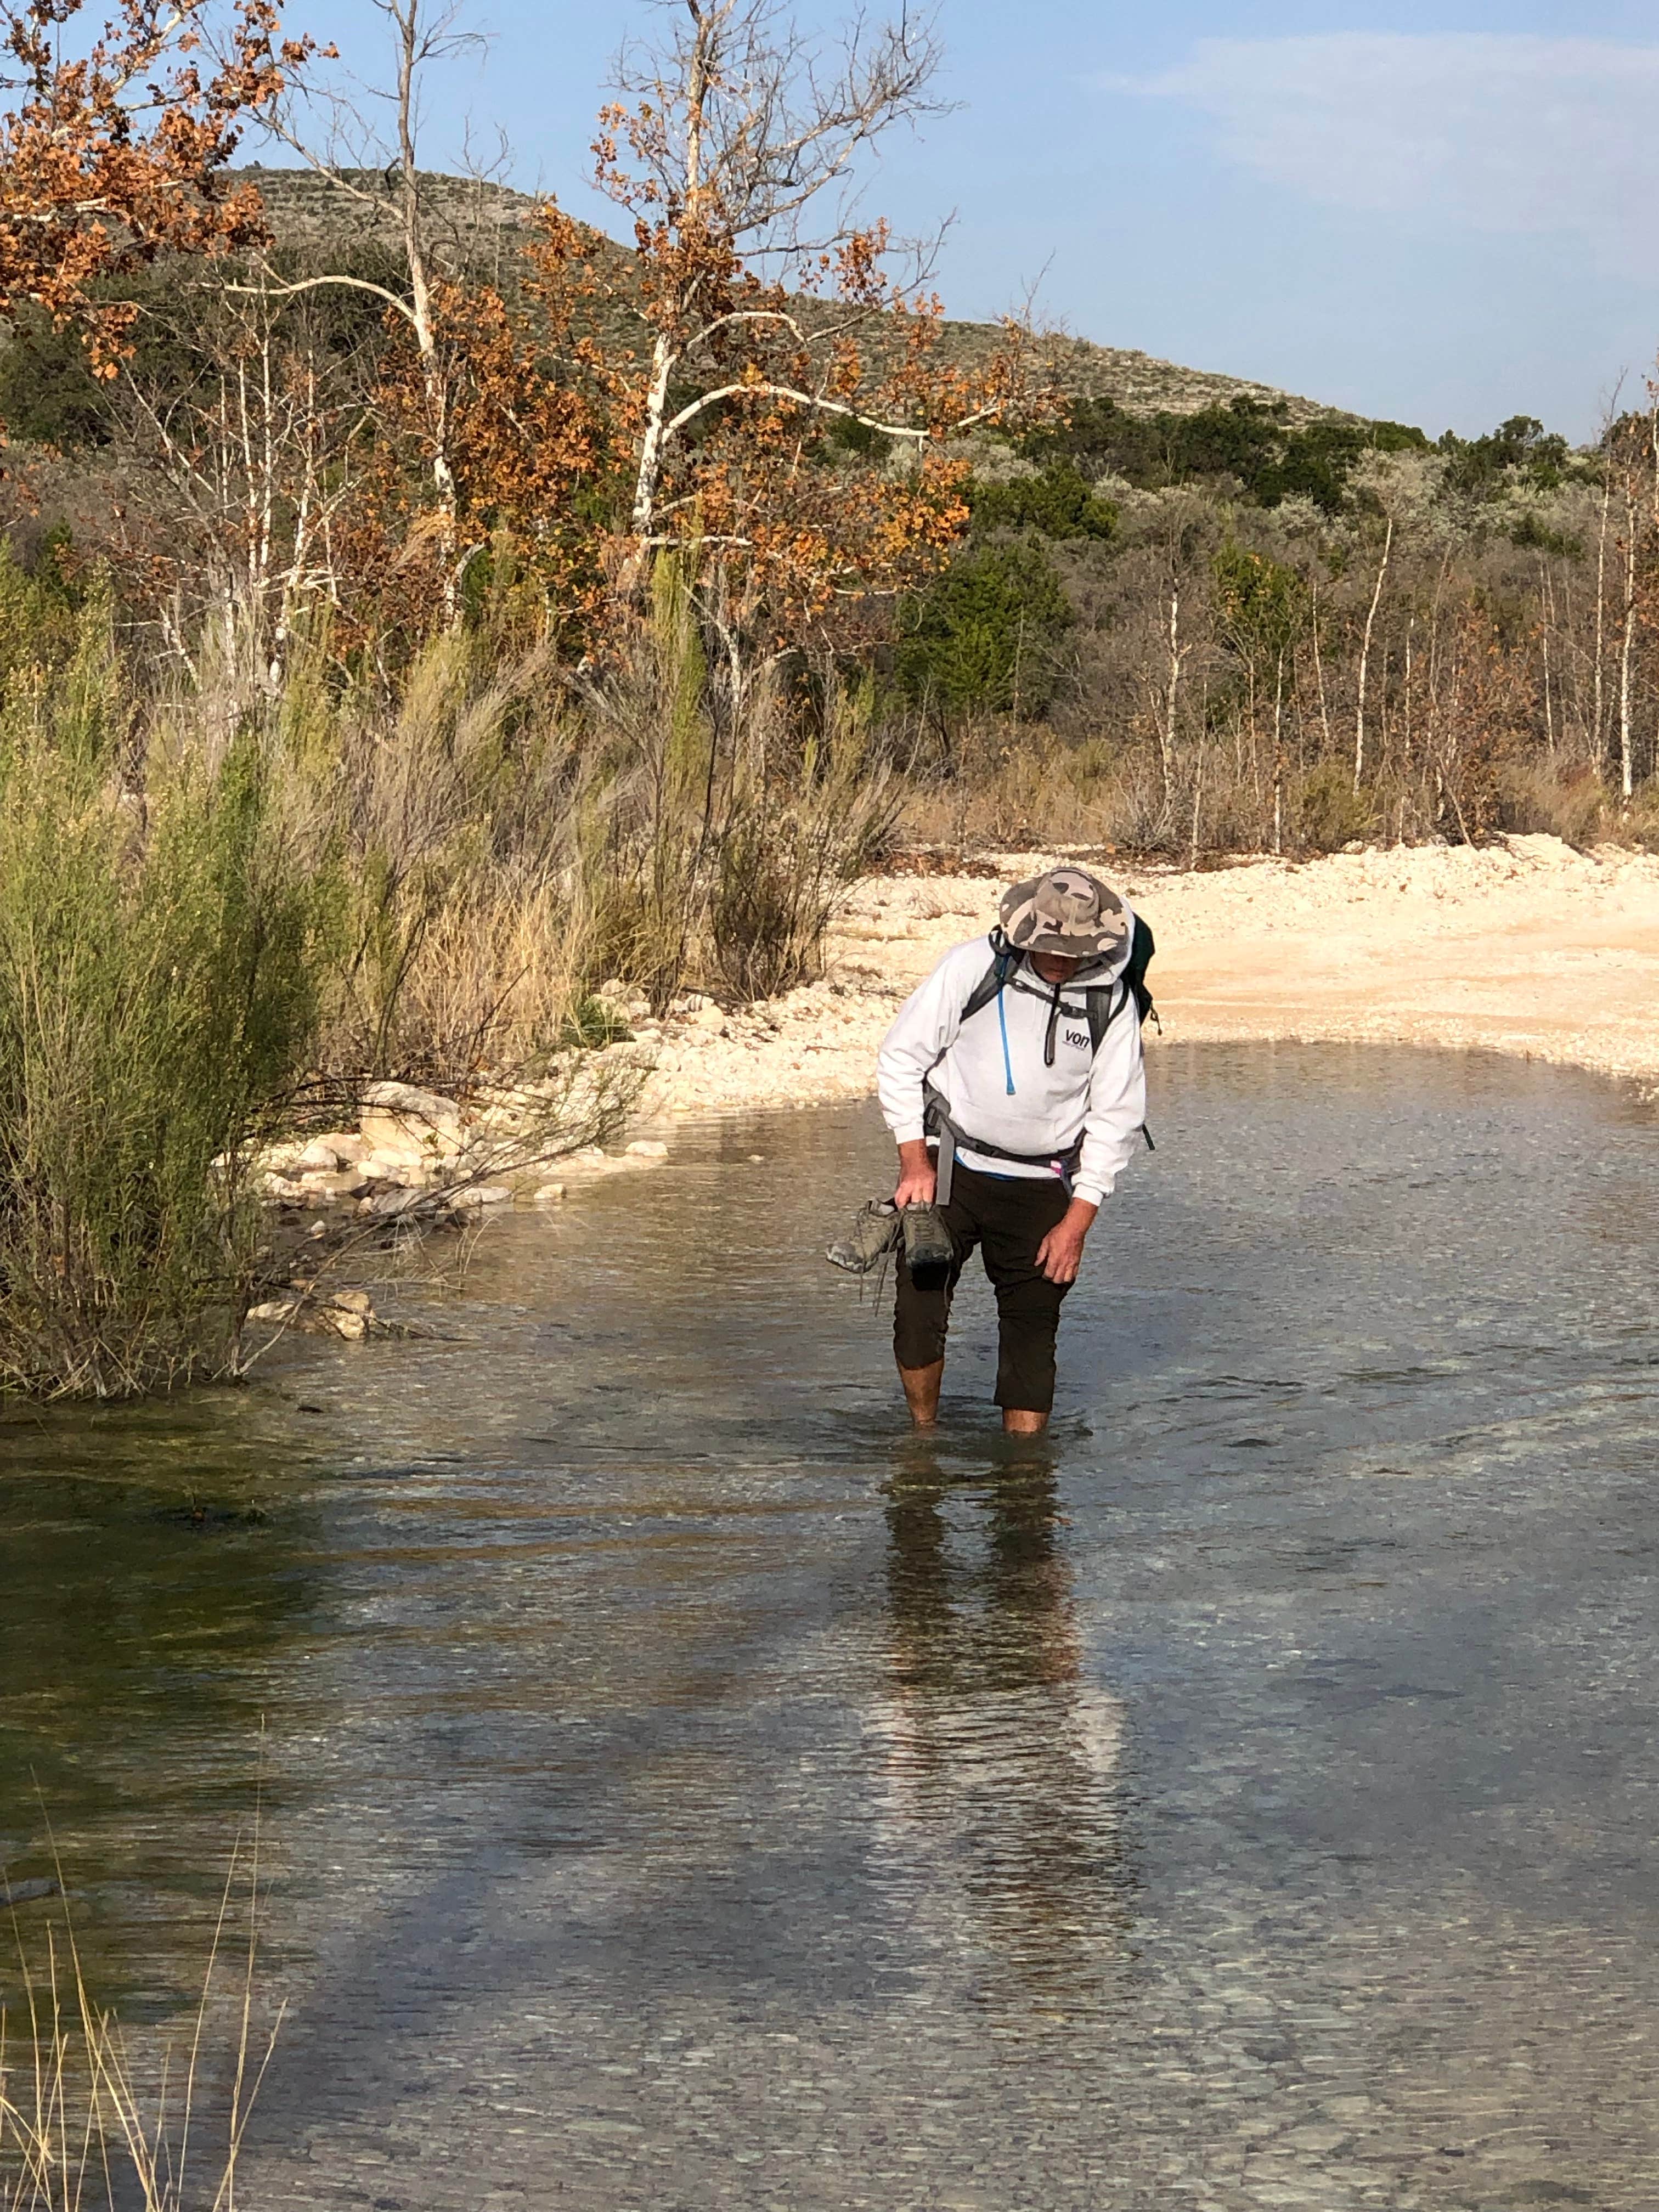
876, 933, 1146, 1205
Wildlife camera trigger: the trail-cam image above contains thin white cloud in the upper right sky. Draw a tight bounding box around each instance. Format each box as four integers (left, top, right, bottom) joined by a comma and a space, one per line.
1099, 31, 1659, 276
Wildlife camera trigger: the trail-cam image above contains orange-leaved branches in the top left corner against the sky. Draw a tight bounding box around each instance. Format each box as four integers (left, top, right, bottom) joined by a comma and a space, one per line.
0, 0, 317, 378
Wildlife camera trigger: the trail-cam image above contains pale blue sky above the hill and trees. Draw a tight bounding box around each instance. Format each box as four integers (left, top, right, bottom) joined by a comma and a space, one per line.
273, 0, 1659, 438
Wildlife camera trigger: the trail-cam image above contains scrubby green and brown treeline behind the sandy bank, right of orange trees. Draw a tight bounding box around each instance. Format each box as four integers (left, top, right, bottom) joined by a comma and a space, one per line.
891, 400, 1659, 856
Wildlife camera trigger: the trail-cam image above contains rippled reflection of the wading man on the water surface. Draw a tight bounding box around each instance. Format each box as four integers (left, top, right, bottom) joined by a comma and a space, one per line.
878, 1469, 1124, 2002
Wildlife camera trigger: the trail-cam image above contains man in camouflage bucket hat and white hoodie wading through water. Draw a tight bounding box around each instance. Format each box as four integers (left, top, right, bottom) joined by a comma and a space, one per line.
878, 867, 1153, 1436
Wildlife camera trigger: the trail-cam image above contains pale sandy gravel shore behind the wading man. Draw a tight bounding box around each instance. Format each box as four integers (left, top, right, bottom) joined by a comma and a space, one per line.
641, 836, 1659, 1121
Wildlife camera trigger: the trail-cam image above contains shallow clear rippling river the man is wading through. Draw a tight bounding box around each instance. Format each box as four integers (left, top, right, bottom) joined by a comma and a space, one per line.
0, 1046, 1659, 2212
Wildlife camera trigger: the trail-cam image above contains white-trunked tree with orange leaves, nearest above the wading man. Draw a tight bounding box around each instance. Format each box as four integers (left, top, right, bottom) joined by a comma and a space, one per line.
595, 0, 1040, 670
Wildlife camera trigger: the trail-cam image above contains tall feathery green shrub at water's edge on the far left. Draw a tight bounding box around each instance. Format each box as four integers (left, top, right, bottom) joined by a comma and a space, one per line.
0, 701, 330, 1398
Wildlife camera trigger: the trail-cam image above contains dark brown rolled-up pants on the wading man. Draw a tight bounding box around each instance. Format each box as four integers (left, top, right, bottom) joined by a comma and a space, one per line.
894, 1159, 1070, 1413
